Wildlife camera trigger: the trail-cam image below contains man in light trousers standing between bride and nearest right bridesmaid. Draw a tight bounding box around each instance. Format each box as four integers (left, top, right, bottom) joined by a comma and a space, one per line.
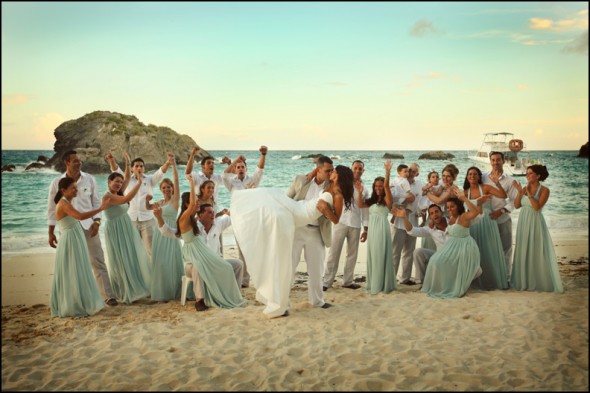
322, 160, 370, 291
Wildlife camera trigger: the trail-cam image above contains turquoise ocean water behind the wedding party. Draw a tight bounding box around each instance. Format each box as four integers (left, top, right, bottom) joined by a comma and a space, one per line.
2, 150, 588, 255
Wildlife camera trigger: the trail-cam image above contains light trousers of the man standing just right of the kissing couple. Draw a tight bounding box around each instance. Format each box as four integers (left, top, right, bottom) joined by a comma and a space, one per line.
324, 224, 361, 288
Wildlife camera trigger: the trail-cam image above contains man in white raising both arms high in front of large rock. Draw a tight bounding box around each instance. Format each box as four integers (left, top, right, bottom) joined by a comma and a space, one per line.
105, 153, 174, 263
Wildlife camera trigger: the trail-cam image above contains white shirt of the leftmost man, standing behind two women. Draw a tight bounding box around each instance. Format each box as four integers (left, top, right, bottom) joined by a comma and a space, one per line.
47, 172, 102, 230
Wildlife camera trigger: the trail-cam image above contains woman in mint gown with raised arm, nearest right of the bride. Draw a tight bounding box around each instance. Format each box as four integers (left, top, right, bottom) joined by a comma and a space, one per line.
355, 160, 396, 295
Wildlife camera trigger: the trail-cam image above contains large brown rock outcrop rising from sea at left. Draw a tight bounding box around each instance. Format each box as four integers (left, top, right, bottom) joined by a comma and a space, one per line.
47, 111, 209, 173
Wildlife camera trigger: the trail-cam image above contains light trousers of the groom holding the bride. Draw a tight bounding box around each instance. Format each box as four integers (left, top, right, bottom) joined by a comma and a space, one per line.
291, 226, 326, 307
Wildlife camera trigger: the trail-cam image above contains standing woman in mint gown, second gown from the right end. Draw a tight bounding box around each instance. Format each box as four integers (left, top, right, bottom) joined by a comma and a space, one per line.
463, 166, 508, 290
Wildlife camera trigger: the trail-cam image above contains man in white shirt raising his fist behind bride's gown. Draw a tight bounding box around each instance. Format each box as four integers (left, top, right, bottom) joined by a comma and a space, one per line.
223, 146, 268, 288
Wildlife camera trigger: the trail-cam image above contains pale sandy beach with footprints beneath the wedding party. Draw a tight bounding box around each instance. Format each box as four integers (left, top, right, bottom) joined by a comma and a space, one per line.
2, 237, 588, 391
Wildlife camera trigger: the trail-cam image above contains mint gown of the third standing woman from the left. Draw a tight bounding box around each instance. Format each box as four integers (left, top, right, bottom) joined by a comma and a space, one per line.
150, 202, 184, 301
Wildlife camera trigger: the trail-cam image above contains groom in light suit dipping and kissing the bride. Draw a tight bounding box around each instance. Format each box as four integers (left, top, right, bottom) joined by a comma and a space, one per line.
287, 156, 334, 308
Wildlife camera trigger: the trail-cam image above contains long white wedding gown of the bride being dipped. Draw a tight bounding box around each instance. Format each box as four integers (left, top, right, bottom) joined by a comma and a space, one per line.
231, 188, 333, 317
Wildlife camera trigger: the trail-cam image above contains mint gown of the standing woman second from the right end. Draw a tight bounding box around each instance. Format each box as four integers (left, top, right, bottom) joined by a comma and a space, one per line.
468, 185, 508, 290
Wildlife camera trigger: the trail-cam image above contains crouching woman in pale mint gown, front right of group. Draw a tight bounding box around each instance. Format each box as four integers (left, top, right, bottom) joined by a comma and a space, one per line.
421, 187, 481, 298
